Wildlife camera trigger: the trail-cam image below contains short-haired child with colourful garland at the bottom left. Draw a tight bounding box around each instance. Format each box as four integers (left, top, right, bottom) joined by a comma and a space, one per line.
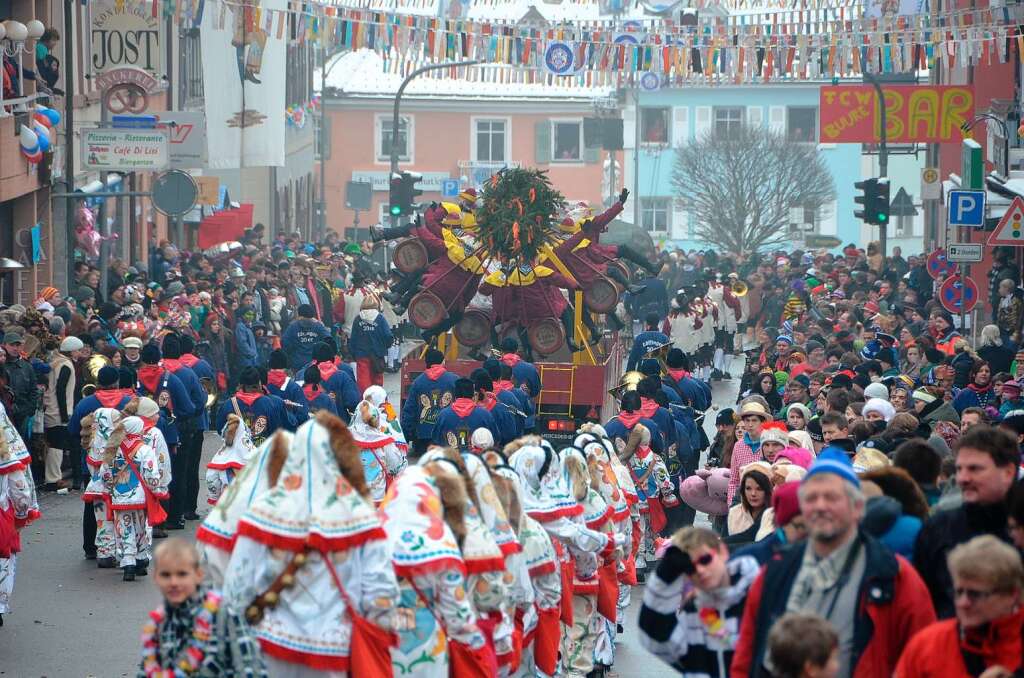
138, 537, 267, 678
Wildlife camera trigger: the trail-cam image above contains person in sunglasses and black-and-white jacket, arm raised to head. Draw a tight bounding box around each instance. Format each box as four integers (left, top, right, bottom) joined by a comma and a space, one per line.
639, 527, 758, 678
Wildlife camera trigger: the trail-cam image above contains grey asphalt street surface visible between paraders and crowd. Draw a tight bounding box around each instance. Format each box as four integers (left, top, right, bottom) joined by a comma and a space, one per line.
0, 370, 738, 678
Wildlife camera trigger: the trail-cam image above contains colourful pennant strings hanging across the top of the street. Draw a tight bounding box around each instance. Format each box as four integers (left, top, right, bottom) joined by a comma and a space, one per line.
186, 0, 1024, 87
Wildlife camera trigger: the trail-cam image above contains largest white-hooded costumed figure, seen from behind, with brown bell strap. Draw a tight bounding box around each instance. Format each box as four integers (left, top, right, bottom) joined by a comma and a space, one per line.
224, 413, 398, 678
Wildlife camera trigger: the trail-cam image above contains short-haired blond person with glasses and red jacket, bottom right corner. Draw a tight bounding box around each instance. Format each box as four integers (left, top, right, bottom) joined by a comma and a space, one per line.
894, 535, 1024, 678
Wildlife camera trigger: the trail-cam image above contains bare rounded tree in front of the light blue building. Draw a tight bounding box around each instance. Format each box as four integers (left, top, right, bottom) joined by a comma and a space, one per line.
672, 125, 836, 256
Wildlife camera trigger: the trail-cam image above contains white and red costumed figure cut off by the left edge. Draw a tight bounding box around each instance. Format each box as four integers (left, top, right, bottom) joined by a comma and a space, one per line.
0, 405, 42, 626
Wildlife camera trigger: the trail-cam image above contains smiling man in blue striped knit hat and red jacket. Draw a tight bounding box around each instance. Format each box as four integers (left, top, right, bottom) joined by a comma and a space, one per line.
731, 448, 935, 678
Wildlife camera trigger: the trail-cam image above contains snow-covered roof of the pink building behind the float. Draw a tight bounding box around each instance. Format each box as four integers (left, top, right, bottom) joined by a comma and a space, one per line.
313, 49, 614, 101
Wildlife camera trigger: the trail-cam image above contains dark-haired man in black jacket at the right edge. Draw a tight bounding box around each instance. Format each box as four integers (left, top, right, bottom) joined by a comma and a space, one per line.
913, 425, 1020, 619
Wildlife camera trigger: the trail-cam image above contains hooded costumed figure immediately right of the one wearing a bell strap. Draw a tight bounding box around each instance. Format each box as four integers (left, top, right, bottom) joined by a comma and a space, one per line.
381, 460, 488, 678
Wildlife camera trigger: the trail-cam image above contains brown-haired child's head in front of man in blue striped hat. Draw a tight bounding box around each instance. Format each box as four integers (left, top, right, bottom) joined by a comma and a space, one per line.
768, 612, 839, 678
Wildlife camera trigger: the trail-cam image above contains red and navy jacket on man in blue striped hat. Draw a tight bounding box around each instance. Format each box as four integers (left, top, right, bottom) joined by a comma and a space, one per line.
730, 532, 935, 678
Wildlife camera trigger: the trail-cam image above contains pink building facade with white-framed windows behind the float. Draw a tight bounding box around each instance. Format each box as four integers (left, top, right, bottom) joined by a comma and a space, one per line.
322, 53, 622, 237
